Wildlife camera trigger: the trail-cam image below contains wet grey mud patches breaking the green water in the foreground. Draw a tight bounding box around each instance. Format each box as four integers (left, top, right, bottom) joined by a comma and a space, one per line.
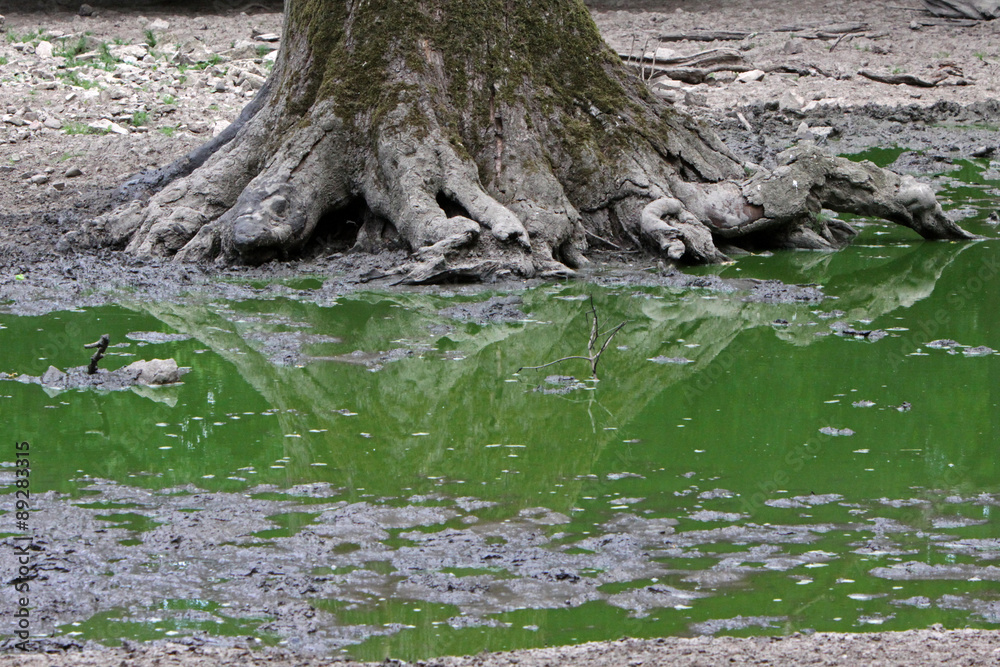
0, 478, 1000, 657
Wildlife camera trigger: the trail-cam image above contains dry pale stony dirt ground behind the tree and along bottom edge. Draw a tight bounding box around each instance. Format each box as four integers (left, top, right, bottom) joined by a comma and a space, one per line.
0, 0, 1000, 666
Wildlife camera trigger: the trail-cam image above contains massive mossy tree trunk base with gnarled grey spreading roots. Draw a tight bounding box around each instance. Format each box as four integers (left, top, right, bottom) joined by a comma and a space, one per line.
68, 0, 969, 282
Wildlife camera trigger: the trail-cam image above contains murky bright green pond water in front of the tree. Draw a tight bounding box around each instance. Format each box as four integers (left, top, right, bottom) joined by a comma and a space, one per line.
0, 158, 1000, 659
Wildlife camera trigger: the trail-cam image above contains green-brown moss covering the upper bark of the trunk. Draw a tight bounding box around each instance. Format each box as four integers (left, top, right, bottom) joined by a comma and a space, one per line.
286, 0, 629, 142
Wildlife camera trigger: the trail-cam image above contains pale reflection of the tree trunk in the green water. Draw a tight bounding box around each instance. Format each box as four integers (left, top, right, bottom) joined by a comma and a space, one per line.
132, 244, 966, 509
